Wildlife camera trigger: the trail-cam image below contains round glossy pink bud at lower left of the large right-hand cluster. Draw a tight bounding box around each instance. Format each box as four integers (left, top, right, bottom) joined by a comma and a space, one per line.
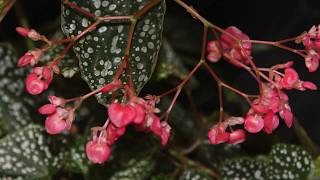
244, 114, 264, 133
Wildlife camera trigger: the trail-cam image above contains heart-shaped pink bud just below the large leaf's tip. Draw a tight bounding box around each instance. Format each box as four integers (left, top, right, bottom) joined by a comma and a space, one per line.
108, 103, 136, 127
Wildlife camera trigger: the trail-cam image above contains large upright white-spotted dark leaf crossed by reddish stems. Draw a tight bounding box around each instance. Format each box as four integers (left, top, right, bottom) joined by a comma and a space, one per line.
62, 0, 165, 105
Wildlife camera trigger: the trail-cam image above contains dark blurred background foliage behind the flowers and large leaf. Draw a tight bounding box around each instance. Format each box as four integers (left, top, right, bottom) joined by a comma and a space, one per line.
0, 0, 320, 180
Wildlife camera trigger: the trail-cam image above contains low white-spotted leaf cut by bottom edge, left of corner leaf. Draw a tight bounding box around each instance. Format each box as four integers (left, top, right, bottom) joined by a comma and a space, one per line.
220, 159, 267, 180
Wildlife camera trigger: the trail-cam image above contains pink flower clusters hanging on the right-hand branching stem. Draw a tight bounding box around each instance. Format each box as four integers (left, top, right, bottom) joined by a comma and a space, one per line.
207, 26, 320, 144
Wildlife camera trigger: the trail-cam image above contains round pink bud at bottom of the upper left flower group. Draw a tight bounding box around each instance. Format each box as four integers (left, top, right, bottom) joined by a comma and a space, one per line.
25, 73, 46, 95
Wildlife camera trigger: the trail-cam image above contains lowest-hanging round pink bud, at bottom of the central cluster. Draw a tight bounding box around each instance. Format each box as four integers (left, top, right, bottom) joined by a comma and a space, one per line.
86, 141, 111, 164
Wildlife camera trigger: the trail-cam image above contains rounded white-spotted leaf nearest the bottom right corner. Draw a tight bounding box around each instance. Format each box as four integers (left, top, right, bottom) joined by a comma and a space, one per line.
267, 144, 312, 179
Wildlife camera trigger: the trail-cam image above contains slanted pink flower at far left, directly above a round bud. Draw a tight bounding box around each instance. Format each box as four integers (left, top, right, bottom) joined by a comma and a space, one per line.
18, 49, 43, 67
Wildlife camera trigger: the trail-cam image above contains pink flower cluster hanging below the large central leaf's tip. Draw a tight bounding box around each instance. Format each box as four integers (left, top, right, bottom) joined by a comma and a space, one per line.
86, 96, 171, 163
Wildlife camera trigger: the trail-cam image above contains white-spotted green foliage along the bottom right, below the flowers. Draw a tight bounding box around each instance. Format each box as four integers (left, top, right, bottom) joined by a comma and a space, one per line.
221, 144, 312, 179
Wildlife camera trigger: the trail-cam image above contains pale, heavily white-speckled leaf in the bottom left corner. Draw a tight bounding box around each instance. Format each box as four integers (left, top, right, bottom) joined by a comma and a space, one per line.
0, 125, 63, 179
